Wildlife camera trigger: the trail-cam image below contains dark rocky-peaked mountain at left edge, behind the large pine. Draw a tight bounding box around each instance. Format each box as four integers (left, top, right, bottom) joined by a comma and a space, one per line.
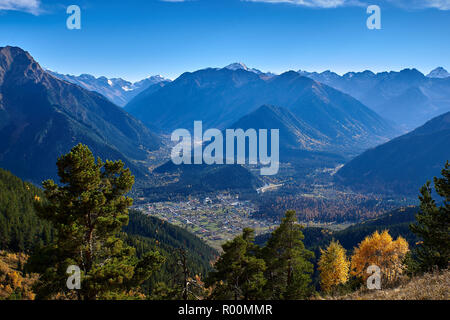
0, 47, 160, 182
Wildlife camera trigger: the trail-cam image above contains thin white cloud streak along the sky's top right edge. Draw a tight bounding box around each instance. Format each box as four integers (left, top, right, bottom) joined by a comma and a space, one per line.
246, 0, 450, 10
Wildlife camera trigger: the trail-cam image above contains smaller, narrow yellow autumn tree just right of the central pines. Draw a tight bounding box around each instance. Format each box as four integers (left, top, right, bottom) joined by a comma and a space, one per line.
319, 241, 350, 292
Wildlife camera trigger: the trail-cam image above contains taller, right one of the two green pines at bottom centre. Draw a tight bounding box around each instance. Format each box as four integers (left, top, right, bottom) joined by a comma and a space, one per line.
263, 210, 314, 300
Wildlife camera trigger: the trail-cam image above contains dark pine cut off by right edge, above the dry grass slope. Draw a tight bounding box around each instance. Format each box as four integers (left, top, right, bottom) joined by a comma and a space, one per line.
410, 161, 450, 272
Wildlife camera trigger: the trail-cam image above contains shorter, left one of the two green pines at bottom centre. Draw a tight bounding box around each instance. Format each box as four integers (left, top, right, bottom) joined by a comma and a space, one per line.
207, 228, 266, 300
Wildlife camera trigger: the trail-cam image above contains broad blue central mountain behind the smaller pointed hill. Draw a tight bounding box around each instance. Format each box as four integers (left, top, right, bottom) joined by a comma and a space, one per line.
125, 68, 395, 156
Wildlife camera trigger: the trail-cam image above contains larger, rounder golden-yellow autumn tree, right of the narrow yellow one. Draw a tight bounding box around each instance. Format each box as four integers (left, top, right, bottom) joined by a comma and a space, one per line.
351, 230, 409, 283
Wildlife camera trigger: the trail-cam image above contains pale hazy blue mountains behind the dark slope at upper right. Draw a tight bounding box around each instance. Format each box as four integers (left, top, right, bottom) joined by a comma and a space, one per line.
299, 68, 450, 131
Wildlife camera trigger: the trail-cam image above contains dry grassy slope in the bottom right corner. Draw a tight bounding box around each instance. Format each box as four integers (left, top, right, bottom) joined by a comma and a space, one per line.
328, 270, 450, 300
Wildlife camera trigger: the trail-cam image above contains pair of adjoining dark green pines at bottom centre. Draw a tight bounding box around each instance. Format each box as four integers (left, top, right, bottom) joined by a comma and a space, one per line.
208, 210, 314, 300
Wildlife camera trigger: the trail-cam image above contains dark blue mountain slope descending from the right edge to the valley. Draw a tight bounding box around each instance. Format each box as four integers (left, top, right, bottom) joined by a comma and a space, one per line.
335, 112, 450, 195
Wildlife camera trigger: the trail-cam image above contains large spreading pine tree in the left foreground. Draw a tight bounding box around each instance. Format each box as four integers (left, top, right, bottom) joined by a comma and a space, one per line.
30, 144, 163, 300
